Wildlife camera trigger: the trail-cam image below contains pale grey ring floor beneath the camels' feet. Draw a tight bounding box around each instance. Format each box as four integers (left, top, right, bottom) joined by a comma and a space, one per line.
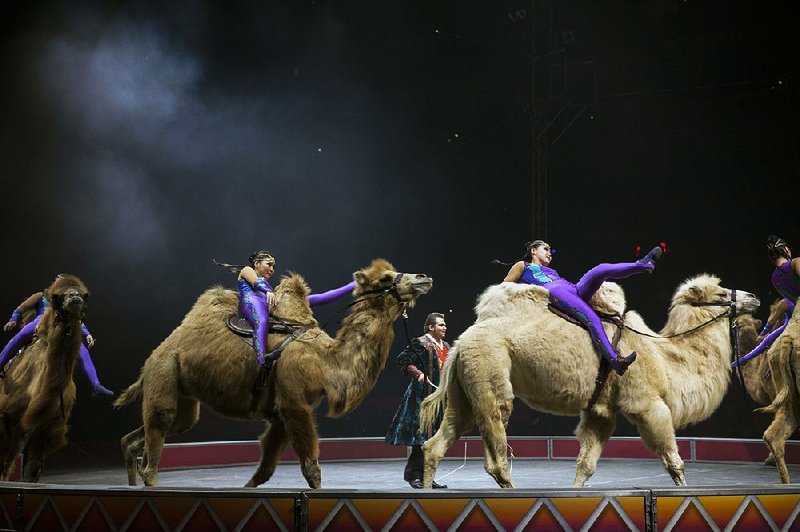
34, 459, 800, 491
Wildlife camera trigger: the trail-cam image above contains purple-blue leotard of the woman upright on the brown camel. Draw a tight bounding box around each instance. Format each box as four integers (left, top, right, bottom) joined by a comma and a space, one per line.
236, 275, 356, 366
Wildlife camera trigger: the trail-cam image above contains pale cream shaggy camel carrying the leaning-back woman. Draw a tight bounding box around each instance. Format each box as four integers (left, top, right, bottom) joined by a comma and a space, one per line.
421, 275, 758, 488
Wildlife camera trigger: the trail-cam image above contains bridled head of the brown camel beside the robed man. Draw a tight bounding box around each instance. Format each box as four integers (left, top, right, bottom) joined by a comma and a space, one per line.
353, 259, 433, 307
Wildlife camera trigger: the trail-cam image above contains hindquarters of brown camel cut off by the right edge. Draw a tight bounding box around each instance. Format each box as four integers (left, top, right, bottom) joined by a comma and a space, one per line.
756, 298, 800, 484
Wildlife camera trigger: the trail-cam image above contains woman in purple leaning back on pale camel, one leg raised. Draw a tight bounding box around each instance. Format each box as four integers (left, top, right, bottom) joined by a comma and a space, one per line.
503, 240, 663, 375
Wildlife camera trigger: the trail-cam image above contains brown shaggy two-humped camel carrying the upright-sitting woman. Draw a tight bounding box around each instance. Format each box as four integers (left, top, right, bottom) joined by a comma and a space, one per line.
114, 259, 433, 488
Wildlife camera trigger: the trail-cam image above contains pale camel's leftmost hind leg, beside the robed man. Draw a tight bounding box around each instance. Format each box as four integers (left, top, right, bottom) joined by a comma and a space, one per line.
422, 383, 475, 488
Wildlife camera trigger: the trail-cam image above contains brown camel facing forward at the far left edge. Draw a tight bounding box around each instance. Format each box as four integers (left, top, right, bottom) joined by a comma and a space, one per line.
0, 275, 89, 482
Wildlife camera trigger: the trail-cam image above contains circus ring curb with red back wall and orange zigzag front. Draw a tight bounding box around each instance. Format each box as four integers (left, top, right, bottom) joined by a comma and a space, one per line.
0, 437, 800, 531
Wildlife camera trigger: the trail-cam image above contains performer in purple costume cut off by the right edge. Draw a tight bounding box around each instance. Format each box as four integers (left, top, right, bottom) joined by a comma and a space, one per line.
731, 235, 800, 367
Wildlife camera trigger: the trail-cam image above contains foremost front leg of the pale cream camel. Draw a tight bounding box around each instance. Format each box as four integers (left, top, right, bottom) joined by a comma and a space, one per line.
628, 401, 686, 486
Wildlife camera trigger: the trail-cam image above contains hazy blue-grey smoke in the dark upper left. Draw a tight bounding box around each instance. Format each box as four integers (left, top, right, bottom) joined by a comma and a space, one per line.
39, 4, 400, 270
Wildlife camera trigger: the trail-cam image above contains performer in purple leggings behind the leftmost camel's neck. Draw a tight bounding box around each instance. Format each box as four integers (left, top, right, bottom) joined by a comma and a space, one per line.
0, 278, 114, 395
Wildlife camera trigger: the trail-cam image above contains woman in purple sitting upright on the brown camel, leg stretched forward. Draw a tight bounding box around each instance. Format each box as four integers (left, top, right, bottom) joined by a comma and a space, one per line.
217, 251, 356, 366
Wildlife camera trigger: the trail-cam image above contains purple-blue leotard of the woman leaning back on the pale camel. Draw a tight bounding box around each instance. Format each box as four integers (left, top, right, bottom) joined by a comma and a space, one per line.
518, 262, 655, 368
